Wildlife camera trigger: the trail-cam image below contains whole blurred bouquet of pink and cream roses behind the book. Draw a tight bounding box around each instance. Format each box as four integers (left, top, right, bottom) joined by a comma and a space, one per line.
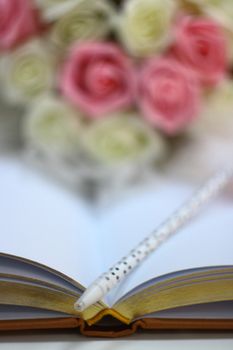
0, 0, 233, 201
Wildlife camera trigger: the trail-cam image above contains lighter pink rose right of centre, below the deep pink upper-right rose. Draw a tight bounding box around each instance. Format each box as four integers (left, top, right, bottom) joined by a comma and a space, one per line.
138, 58, 200, 134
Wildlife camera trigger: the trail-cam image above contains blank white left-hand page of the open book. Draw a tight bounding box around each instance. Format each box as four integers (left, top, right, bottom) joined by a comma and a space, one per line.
0, 158, 102, 286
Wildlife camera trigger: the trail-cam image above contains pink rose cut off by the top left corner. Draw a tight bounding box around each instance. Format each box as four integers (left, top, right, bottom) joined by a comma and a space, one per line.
0, 0, 39, 50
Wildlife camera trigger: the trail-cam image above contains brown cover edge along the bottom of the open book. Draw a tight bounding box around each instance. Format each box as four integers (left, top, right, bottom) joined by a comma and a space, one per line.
0, 317, 233, 338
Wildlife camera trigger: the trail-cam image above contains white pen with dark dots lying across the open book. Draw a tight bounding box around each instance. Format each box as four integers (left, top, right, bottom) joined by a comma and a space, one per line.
74, 168, 233, 312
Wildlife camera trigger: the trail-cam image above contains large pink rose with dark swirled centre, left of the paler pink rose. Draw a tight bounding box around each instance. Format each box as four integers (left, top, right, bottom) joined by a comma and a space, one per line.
60, 42, 135, 118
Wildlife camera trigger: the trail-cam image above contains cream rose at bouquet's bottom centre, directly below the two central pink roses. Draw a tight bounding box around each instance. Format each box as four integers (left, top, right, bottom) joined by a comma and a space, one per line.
82, 113, 166, 166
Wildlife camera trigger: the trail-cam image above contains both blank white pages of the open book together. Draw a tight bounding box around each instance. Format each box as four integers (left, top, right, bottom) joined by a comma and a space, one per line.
0, 159, 233, 303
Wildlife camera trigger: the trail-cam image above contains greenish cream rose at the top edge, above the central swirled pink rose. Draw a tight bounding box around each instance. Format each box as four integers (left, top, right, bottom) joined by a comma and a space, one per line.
50, 0, 114, 49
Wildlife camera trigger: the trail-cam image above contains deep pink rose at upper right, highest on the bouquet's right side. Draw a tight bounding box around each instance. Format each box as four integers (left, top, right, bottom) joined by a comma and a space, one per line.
174, 17, 227, 85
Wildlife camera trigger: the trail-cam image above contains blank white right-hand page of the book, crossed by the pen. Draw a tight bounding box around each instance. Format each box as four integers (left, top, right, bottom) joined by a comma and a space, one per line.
98, 183, 233, 305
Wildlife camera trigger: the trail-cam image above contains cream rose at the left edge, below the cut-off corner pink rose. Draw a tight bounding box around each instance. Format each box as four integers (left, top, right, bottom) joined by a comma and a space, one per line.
1, 40, 56, 103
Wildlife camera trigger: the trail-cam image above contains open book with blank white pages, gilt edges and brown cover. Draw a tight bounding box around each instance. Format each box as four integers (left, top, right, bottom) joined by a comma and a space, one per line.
0, 159, 233, 336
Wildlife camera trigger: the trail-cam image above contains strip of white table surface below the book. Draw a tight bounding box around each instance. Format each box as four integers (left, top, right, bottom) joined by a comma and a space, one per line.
0, 333, 233, 350
